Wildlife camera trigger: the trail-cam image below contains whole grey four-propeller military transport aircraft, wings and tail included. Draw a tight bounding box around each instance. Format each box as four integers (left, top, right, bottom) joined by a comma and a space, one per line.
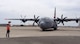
6, 8, 80, 31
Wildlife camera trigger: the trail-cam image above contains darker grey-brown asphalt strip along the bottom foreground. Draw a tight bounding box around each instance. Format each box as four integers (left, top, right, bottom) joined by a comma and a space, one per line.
0, 36, 80, 44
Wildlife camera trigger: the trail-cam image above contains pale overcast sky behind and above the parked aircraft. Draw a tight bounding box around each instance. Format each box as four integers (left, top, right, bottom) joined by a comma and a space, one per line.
0, 0, 80, 26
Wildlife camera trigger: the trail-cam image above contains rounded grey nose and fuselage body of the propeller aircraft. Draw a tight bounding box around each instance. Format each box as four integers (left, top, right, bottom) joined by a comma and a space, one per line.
38, 17, 57, 30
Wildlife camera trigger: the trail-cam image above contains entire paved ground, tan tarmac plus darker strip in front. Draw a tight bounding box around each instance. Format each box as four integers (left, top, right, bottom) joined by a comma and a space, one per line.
0, 27, 80, 44
